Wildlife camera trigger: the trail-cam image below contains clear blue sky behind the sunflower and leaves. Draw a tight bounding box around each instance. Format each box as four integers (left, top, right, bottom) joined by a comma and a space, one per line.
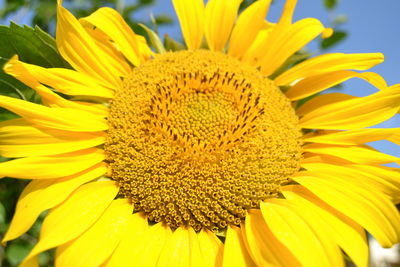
0, 0, 400, 156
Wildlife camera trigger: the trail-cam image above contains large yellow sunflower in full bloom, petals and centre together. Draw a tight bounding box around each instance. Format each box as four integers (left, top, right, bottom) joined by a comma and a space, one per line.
0, 0, 400, 267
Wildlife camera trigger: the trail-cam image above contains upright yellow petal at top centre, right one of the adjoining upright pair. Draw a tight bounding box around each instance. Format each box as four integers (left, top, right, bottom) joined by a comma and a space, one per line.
204, 0, 243, 51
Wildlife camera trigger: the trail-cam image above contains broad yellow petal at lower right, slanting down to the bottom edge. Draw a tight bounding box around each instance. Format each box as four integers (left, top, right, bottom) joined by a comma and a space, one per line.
260, 199, 344, 266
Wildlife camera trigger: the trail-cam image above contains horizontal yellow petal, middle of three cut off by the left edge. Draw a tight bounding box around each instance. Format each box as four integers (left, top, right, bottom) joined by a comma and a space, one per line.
0, 119, 105, 158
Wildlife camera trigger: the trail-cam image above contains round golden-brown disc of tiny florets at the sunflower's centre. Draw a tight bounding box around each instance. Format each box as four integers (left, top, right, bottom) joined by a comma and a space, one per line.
105, 50, 301, 231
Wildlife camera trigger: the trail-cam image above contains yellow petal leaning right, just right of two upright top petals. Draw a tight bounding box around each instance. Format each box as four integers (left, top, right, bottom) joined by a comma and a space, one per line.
228, 0, 271, 58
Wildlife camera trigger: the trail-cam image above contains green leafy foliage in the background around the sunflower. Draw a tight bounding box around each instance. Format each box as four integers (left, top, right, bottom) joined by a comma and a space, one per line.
0, 0, 347, 267
